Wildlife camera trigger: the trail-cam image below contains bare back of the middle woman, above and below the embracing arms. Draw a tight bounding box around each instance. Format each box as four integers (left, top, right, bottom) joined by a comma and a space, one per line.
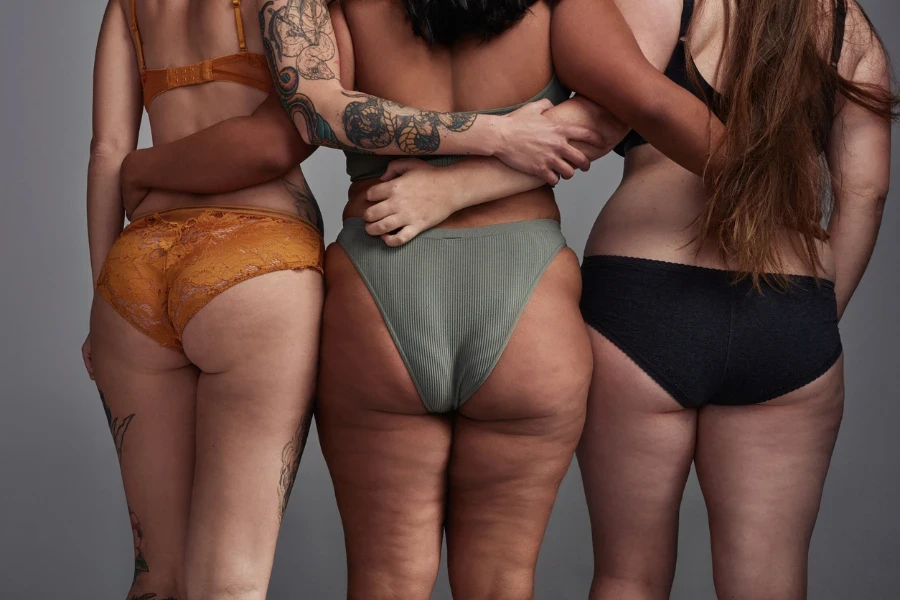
335, 0, 559, 227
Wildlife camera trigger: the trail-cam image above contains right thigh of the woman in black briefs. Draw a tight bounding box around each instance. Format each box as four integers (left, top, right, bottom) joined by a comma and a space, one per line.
696, 360, 844, 599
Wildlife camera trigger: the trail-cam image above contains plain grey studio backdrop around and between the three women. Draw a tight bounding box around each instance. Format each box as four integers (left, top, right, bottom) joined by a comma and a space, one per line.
0, 0, 900, 600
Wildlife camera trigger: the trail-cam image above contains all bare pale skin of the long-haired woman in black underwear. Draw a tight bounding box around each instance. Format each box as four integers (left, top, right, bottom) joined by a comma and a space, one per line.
367, 0, 890, 600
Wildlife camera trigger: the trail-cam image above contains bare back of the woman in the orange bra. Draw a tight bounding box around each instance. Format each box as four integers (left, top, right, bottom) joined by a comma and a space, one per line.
118, 0, 304, 218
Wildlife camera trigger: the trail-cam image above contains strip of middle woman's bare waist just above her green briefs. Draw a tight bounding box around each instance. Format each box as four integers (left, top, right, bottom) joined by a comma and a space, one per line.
343, 179, 560, 229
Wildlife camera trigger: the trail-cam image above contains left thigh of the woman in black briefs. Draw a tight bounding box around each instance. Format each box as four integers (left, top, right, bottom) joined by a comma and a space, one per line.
578, 329, 697, 600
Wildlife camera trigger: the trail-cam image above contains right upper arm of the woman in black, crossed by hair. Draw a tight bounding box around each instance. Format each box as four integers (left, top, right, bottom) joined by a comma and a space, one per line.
827, 7, 891, 204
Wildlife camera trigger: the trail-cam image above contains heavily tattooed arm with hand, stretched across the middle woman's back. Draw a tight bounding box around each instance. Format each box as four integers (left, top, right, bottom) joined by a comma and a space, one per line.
258, 0, 592, 181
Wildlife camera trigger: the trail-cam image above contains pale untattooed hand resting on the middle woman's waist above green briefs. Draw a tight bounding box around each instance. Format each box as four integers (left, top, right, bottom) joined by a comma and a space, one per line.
363, 158, 463, 246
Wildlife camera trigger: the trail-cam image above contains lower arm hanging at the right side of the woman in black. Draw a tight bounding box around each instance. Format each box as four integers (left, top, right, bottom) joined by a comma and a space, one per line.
828, 196, 884, 317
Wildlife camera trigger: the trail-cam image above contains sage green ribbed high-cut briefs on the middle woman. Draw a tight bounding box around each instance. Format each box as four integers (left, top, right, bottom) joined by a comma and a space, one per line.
337, 219, 566, 413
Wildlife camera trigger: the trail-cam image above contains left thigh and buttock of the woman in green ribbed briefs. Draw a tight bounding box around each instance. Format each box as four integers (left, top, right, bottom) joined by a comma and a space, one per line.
316, 244, 451, 600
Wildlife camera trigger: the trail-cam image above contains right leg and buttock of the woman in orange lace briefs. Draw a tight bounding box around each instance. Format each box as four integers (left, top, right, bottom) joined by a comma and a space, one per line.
183, 270, 323, 600
